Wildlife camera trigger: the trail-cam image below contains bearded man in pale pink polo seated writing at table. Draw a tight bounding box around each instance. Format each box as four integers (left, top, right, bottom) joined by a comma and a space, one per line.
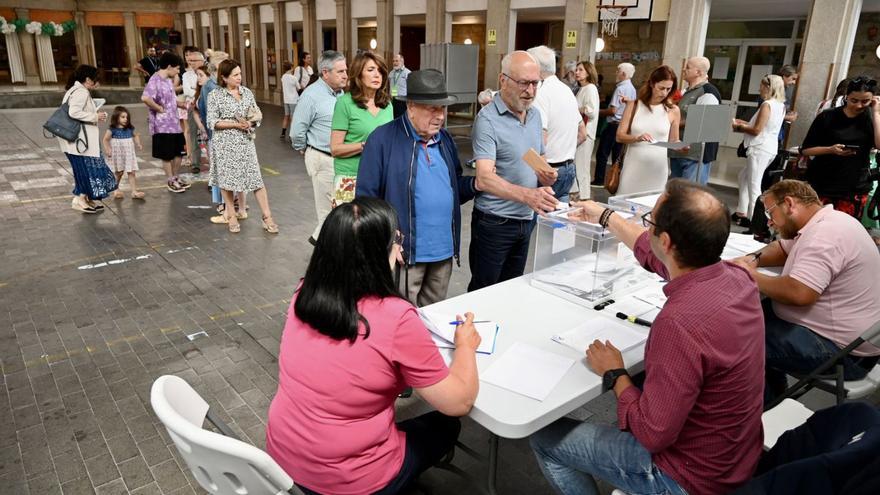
736, 180, 880, 403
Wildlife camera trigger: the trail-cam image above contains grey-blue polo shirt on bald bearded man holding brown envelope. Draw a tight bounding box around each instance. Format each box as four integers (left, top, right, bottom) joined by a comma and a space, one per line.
471, 93, 544, 220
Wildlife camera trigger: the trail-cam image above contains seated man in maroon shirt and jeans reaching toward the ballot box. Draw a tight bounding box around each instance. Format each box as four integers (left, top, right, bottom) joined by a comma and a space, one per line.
531, 179, 764, 495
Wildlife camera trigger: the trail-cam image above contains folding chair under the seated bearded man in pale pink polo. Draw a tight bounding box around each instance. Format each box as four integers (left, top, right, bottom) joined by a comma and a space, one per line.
765, 321, 880, 411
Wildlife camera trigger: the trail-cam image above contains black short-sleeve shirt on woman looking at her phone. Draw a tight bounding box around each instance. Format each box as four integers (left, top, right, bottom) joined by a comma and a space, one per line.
802, 107, 874, 196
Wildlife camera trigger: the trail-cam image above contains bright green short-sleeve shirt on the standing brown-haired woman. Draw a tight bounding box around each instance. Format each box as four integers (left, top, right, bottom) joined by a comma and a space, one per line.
331, 93, 394, 177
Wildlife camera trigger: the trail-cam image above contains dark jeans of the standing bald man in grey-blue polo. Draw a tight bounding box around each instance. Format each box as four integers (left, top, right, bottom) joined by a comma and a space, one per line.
468, 208, 535, 292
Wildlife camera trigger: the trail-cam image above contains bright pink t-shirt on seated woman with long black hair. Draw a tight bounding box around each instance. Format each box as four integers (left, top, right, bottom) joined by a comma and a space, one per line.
266, 295, 449, 495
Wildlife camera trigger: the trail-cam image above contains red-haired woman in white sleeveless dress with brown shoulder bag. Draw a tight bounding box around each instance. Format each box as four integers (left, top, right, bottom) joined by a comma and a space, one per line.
617, 65, 681, 194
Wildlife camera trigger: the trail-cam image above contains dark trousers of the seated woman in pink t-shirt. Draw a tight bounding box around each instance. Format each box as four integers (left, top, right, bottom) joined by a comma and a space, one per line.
297, 411, 461, 495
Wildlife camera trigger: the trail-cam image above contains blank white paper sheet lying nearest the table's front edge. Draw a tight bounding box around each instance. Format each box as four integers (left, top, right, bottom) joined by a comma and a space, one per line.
480, 342, 575, 401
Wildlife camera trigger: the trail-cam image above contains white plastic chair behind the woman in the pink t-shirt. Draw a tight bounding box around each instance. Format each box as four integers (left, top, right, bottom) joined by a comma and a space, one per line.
150, 375, 302, 495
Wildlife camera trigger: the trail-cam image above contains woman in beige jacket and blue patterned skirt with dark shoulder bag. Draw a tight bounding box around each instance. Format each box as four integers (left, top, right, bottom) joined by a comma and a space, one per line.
58, 65, 118, 213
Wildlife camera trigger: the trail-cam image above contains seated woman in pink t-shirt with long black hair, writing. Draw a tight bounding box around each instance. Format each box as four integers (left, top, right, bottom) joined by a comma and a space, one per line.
266, 198, 480, 495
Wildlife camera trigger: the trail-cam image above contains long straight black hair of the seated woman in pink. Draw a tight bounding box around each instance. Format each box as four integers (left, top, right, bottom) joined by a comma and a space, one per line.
293, 198, 401, 343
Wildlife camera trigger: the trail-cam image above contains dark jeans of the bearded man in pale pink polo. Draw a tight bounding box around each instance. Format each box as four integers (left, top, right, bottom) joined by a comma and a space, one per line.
761, 299, 877, 404
